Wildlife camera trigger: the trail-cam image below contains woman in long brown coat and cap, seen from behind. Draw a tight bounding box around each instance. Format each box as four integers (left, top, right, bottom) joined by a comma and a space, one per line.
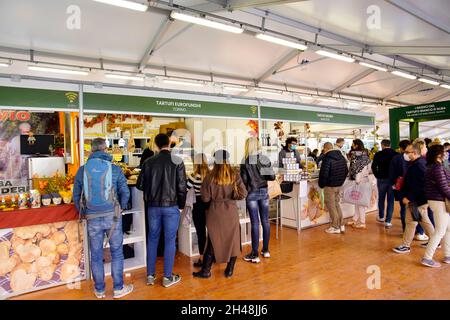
193, 150, 247, 278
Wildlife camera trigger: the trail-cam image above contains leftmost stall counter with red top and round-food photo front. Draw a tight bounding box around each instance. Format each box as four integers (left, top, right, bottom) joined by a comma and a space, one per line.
0, 204, 86, 299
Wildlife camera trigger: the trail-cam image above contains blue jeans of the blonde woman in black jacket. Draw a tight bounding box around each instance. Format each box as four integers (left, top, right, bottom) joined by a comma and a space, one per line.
247, 188, 270, 255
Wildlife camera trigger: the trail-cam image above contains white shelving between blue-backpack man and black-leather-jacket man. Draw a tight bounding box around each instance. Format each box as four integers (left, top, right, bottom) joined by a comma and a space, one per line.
105, 187, 147, 275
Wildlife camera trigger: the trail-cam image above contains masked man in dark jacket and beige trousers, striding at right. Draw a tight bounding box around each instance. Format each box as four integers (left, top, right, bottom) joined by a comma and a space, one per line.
393, 139, 434, 254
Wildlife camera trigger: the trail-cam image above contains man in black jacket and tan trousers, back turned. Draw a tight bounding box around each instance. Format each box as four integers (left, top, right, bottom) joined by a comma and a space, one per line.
319, 142, 348, 233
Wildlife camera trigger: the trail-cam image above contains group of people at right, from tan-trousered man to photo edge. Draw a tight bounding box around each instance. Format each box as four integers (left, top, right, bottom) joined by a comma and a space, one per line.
319, 138, 450, 267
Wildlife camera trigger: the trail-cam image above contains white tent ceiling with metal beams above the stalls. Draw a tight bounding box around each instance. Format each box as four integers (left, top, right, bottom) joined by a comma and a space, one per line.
0, 0, 450, 138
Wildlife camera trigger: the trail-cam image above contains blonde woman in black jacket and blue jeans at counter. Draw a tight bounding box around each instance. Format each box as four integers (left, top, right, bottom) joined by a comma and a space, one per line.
241, 137, 275, 263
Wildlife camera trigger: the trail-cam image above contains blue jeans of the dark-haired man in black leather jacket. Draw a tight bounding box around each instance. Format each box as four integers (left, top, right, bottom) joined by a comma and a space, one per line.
147, 206, 180, 278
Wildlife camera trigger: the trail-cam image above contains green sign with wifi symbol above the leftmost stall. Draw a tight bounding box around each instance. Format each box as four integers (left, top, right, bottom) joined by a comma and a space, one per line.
0, 86, 78, 109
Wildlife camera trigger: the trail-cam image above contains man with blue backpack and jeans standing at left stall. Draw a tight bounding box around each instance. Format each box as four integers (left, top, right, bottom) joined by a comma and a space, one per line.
73, 138, 133, 299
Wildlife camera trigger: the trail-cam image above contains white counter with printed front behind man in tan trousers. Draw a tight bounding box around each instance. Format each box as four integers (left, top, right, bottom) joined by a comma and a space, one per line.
280, 175, 378, 229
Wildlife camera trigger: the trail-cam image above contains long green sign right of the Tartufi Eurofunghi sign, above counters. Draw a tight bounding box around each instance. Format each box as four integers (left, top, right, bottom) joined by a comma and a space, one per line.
261, 107, 375, 126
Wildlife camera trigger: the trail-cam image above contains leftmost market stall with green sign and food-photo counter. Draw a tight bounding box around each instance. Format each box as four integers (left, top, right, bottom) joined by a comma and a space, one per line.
0, 87, 86, 299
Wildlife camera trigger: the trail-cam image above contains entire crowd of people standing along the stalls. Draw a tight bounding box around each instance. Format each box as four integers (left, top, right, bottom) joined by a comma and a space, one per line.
74, 134, 450, 298
